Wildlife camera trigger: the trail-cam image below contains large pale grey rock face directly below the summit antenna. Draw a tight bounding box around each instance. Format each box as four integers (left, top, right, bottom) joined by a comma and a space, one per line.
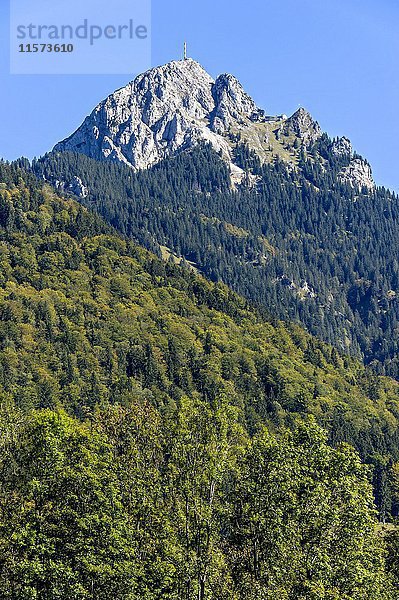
54, 59, 262, 169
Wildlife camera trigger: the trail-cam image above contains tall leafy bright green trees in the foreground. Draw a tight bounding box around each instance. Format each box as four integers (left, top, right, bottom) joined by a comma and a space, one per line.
0, 406, 394, 600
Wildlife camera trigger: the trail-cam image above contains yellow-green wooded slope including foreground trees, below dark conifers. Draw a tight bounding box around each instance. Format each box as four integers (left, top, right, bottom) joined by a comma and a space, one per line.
0, 164, 399, 600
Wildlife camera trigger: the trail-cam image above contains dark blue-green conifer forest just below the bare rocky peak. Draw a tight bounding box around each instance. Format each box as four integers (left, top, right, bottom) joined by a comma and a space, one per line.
33, 141, 399, 377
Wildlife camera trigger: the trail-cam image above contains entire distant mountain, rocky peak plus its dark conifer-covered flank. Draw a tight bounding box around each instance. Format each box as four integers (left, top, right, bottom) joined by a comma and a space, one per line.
28, 60, 399, 377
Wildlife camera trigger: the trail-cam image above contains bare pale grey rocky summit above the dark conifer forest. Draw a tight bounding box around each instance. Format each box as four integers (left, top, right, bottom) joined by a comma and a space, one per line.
54, 59, 373, 188
